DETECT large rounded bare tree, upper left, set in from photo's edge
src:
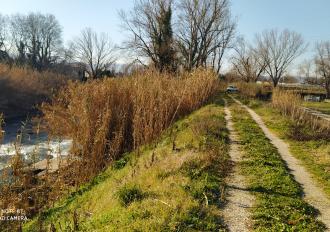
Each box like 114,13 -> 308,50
11,13 -> 62,70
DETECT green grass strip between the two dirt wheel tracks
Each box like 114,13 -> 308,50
232,104 -> 325,231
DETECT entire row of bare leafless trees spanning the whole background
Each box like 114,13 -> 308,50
0,0 -> 330,96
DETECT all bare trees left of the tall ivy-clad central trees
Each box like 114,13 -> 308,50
0,13 -> 115,78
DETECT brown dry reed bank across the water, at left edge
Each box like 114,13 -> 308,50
0,64 -> 72,118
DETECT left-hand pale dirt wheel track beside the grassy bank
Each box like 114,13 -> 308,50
223,99 -> 254,232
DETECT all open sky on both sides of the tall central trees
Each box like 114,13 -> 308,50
0,0 -> 330,72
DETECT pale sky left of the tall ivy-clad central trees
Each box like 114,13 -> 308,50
0,0 -> 133,43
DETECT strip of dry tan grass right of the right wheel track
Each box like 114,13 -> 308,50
272,89 -> 330,137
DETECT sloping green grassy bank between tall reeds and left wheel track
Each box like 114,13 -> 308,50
23,95 -> 230,232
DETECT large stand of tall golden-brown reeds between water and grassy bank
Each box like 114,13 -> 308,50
42,70 -> 218,181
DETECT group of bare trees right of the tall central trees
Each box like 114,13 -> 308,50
231,30 -> 330,98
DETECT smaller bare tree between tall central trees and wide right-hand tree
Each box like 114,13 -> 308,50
231,38 -> 266,82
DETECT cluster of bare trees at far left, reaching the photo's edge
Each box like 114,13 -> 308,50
0,13 -> 62,70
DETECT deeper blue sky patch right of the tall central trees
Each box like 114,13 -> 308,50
232,0 -> 330,50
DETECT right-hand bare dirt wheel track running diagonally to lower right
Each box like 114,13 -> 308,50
233,98 -> 330,230
